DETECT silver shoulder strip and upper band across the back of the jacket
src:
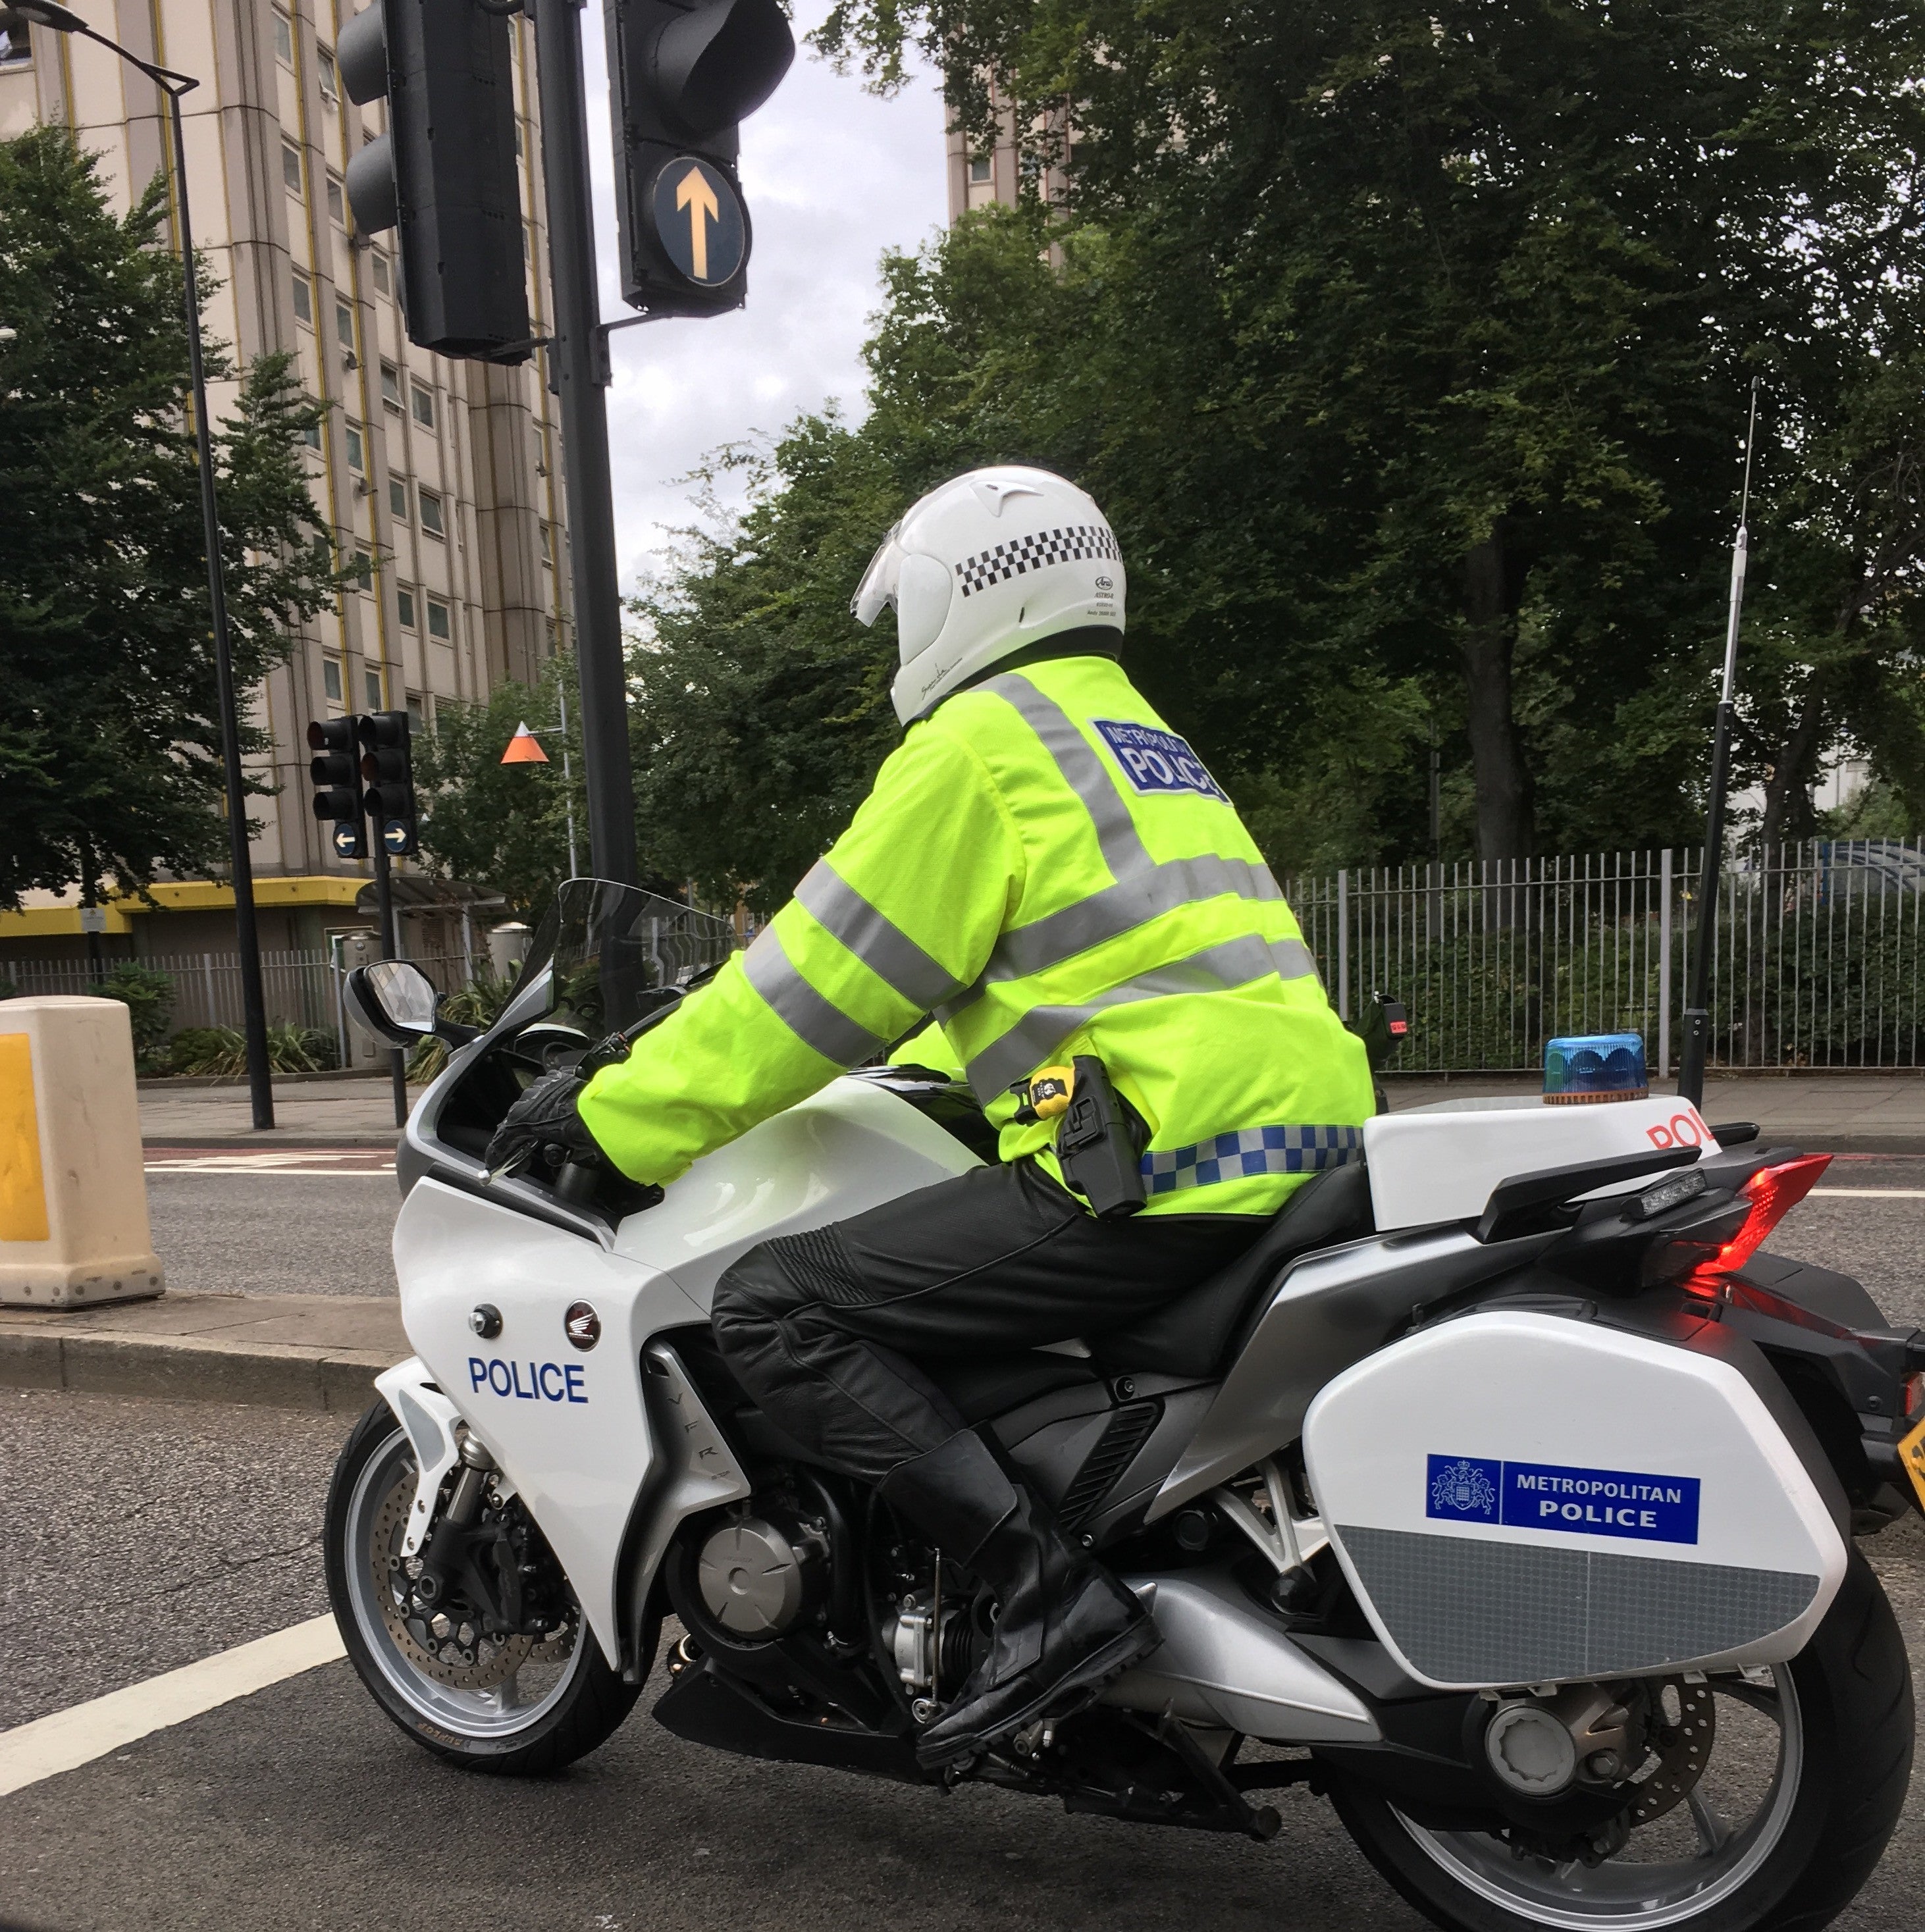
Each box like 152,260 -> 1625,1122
937,672 -> 1316,1024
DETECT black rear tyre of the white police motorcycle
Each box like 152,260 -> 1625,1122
1328,1550 -> 1913,1932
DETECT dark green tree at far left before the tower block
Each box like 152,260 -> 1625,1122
0,128 -> 336,906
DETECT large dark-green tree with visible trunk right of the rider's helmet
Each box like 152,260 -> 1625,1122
788,0 -> 1925,858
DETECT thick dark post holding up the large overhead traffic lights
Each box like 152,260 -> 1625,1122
533,0 -> 636,885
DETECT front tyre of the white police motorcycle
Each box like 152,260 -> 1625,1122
325,1401 -> 649,1777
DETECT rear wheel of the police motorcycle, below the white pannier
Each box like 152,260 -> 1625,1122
1332,1550 -> 1911,1932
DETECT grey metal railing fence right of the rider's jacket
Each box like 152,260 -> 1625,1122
1283,841 -> 1925,1072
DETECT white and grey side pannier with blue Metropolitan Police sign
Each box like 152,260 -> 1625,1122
1303,1310 -> 1846,1688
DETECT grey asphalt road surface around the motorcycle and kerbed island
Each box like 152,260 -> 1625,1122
0,1161 -> 1925,1932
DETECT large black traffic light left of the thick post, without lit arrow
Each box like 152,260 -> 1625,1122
334,0 -> 525,363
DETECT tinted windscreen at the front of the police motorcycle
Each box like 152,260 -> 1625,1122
522,879 -> 737,1039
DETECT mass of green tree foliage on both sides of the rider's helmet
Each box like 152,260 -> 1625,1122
634,0 -> 1925,889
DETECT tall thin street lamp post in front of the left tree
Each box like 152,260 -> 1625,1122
0,0 -> 275,1128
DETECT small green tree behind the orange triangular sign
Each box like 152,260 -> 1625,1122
413,657 -> 587,922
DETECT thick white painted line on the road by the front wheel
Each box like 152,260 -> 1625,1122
0,1617 -> 348,1797
